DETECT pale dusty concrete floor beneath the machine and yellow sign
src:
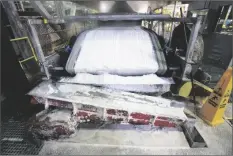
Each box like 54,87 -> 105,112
40,105 -> 232,155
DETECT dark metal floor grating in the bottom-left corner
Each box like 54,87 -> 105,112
1,119 -> 43,155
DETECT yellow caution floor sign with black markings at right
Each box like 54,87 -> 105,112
200,67 -> 232,126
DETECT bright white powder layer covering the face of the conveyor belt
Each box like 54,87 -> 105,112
72,27 -> 158,75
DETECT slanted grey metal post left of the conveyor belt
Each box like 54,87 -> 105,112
29,21 -> 50,79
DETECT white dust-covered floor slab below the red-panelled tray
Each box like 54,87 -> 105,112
40,129 -> 189,149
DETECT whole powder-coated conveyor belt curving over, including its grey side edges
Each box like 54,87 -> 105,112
66,27 -> 167,75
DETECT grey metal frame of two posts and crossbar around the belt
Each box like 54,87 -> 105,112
28,14 -> 202,80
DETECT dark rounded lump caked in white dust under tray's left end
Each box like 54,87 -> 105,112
29,109 -> 77,140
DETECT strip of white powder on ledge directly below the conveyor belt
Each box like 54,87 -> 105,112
59,73 -> 174,93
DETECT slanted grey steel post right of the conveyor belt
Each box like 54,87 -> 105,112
182,16 -> 202,80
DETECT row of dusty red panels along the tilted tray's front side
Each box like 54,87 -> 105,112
31,95 -> 182,127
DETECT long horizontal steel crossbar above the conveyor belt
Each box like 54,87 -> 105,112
27,14 -> 195,24
